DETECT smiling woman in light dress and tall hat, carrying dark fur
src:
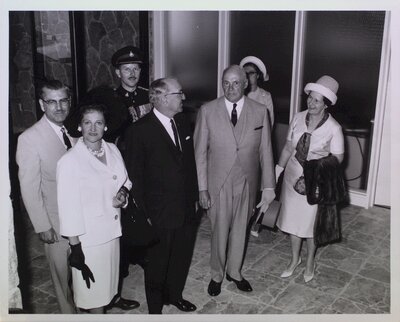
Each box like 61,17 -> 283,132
275,76 -> 344,283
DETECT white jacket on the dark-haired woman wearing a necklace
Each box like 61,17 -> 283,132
57,140 -> 132,247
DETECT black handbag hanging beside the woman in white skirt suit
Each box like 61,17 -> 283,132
121,195 -> 159,246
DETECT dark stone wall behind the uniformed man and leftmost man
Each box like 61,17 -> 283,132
9,11 -> 148,133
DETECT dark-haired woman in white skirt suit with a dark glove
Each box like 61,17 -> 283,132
57,104 -> 132,313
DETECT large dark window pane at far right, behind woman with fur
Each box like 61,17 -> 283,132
303,11 -> 385,189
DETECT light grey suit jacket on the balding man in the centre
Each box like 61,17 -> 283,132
194,97 -> 275,204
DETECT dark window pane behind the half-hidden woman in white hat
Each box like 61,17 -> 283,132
230,11 -> 295,124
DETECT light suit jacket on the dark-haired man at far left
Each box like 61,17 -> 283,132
16,115 -> 77,233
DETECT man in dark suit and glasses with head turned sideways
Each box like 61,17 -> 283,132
125,78 -> 198,314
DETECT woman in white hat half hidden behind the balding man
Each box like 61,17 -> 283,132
239,56 -> 274,128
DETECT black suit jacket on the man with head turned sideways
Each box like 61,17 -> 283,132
125,111 -> 198,229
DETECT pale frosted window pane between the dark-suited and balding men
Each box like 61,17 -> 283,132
165,11 -> 218,111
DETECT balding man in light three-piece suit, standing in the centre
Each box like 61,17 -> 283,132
194,65 -> 275,296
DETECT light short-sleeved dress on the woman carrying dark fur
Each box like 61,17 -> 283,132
277,110 -> 344,238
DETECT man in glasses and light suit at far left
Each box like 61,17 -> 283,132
16,80 -> 76,314
